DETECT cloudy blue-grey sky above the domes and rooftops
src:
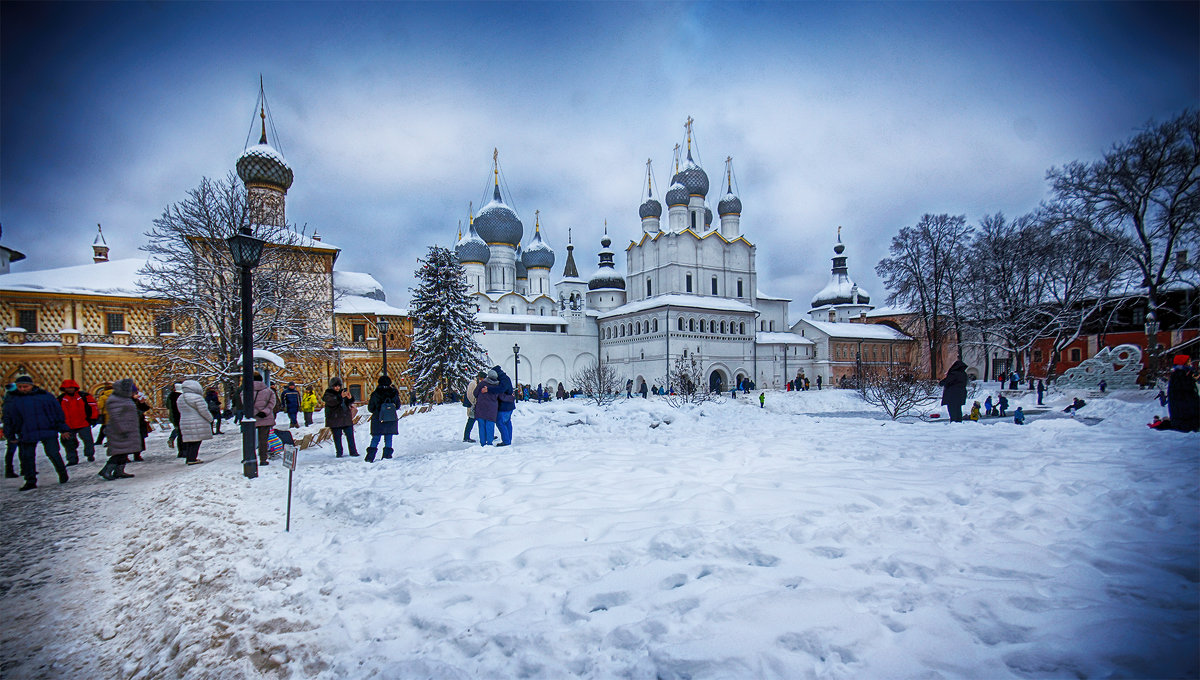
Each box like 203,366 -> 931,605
0,2 -> 1200,320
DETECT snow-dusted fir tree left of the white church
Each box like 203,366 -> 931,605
408,246 -> 485,395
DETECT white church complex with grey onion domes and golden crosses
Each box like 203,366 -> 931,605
455,119 -> 913,392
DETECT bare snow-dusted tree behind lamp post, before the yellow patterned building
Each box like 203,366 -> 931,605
139,173 -> 334,398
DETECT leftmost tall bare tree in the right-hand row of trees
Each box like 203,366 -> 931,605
875,215 -> 971,378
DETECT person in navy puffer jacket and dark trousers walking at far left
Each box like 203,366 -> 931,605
4,375 -> 68,491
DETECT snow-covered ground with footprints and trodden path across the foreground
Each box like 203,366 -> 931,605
0,390 -> 1200,679
